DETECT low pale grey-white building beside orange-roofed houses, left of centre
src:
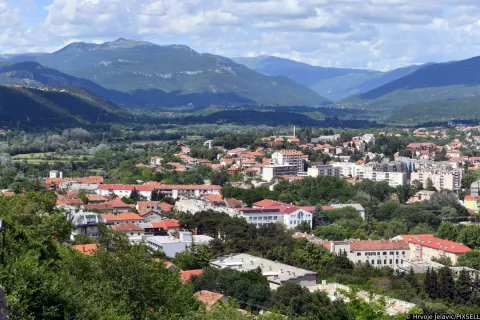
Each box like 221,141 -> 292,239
146,231 -> 213,258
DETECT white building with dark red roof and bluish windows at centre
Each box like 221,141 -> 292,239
235,205 -> 313,229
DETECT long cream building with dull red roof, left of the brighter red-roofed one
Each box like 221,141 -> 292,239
318,239 -> 410,269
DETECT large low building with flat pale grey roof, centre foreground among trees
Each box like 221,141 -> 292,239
210,253 -> 317,289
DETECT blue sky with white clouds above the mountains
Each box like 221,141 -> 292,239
0,0 -> 480,70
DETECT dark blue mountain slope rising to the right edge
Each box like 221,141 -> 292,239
341,57 -> 480,111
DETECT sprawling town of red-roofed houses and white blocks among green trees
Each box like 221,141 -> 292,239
0,126 -> 480,316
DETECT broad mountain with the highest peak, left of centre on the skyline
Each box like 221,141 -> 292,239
9,39 -> 327,106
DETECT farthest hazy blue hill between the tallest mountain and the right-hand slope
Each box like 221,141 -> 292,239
233,56 -> 421,101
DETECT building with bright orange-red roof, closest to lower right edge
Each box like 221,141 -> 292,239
394,234 -> 472,264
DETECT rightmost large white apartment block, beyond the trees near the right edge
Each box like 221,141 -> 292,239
410,168 -> 463,191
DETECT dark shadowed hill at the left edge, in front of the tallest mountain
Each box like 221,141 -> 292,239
0,86 -> 120,124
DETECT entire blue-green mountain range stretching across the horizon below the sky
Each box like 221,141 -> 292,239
0,38 -> 480,122
